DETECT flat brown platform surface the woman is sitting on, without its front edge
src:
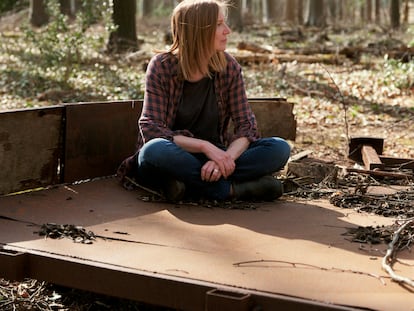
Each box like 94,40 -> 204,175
0,179 -> 414,310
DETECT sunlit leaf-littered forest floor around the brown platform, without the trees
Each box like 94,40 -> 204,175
0,13 -> 414,310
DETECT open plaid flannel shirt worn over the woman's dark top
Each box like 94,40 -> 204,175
118,52 -> 259,183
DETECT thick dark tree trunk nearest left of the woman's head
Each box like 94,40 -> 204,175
107,0 -> 139,53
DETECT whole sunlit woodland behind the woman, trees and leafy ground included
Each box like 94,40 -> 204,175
0,0 -> 414,310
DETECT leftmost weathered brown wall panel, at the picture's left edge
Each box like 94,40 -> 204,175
0,107 -> 63,194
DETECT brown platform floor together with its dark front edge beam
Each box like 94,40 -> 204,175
0,178 -> 414,311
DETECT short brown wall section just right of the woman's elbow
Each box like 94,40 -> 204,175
249,98 -> 296,141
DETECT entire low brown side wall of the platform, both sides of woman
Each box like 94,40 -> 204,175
0,98 -> 296,189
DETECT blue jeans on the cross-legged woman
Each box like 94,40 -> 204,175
136,137 -> 290,200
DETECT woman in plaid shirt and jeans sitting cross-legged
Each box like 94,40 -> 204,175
118,0 -> 290,201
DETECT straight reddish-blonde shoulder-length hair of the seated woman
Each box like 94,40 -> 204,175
169,0 -> 227,80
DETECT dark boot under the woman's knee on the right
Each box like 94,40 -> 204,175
233,176 -> 283,201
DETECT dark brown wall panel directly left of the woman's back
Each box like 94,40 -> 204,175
64,101 -> 142,182
